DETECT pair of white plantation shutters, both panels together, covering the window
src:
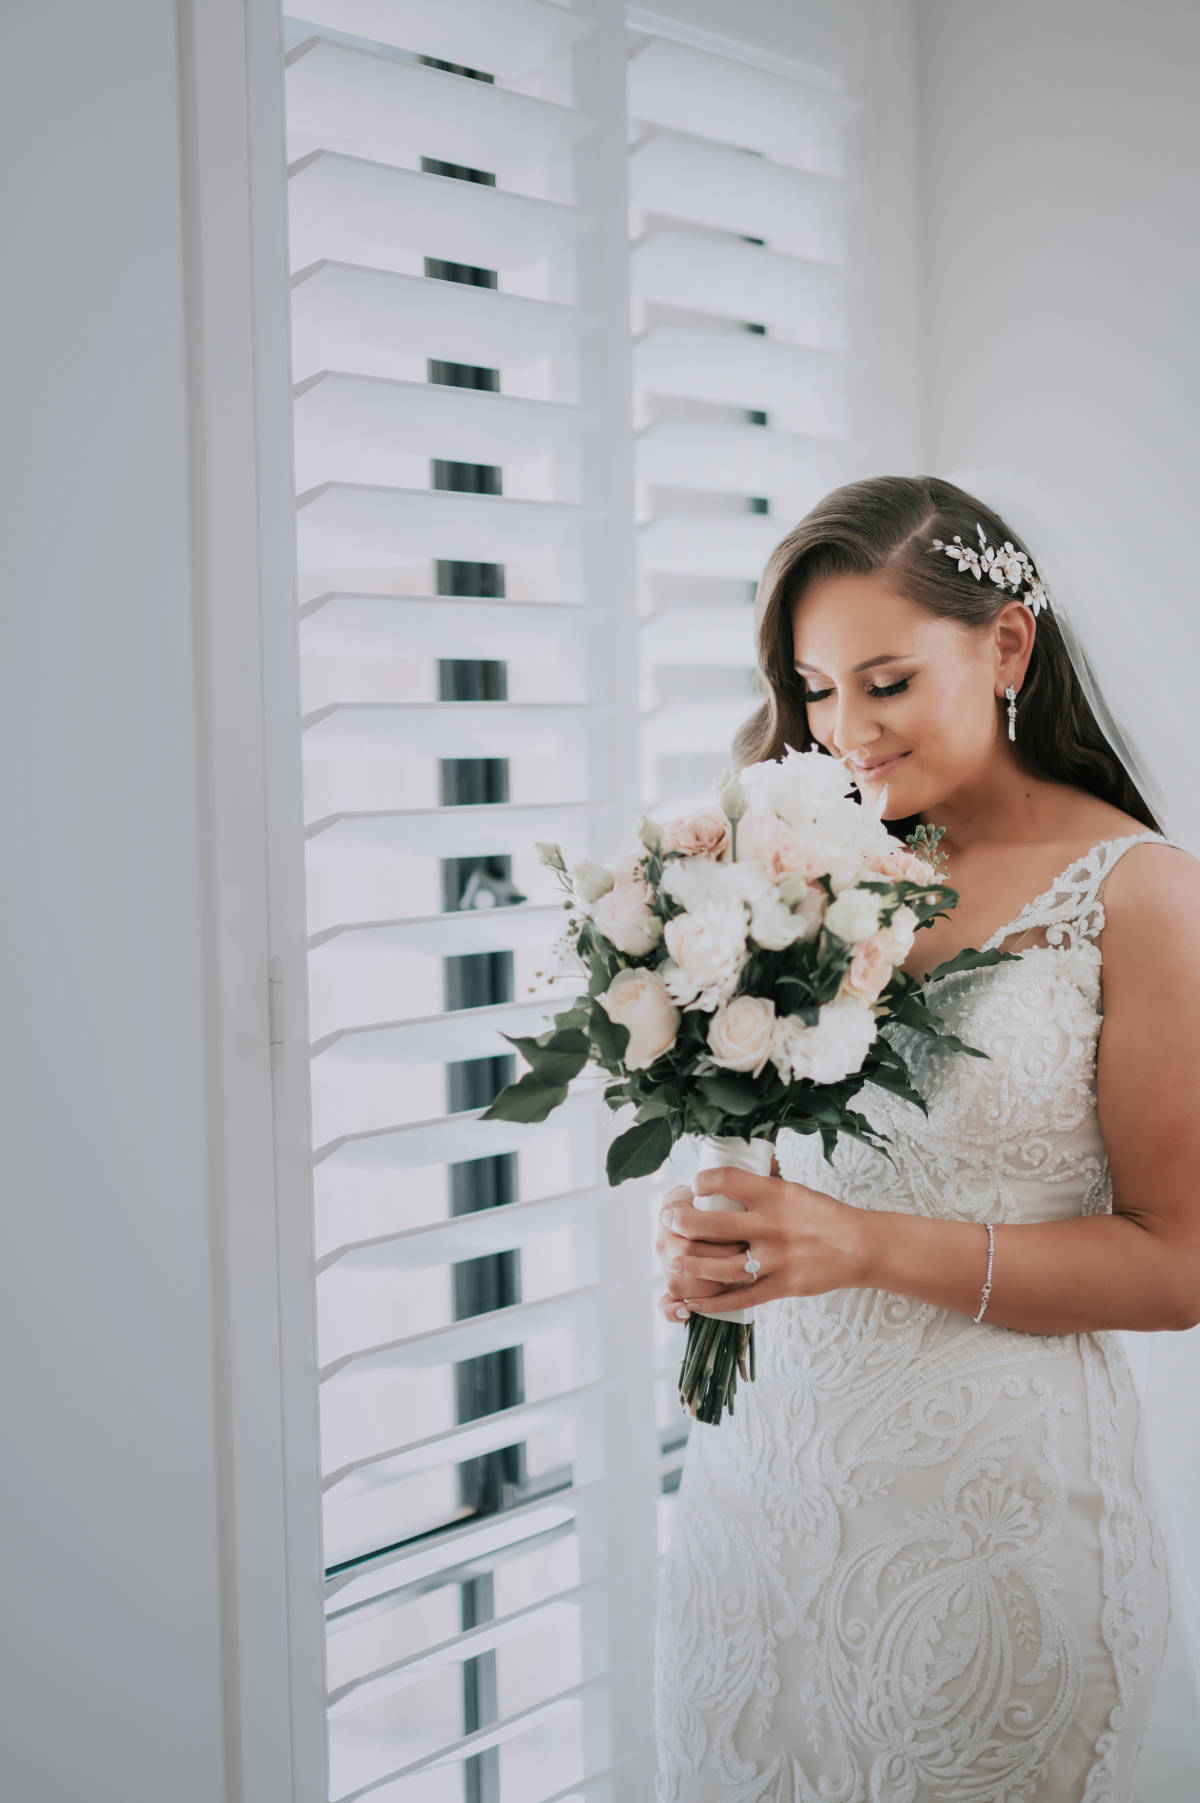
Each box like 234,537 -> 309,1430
285,0 -> 850,1803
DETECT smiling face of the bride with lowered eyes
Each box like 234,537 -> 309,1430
793,573 -> 1004,820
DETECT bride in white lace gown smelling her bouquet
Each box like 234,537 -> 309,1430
654,476 -> 1200,1803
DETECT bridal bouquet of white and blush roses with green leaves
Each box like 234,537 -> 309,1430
483,746 -> 1009,1423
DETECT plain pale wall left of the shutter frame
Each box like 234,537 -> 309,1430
0,0 -> 225,1803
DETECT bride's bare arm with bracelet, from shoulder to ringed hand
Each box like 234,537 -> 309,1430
672,846 -> 1200,1334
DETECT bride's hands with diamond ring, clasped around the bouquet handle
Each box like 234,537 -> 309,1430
663,1165 -> 868,1314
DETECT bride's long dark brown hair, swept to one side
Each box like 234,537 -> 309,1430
733,476 -> 1160,831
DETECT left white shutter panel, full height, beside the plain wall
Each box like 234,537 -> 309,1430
285,0 -> 656,1803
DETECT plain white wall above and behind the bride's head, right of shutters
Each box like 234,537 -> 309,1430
915,0 -> 1200,842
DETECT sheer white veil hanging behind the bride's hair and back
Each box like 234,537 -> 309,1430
948,467 -> 1200,1803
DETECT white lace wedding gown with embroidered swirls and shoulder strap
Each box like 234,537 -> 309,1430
654,833 -> 1175,1803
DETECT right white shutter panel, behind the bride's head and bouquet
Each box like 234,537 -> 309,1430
629,7 -> 854,811
